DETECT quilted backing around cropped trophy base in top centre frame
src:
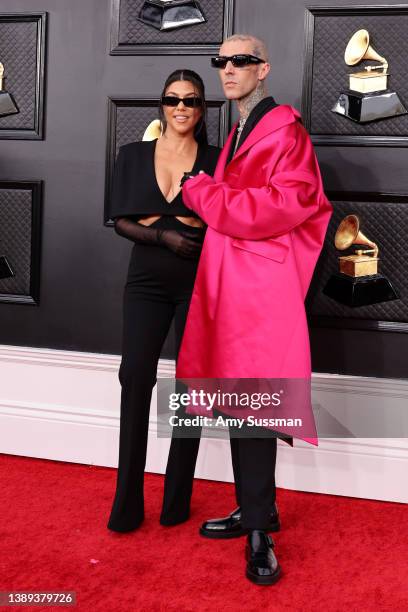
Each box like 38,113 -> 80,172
116,0 -> 229,52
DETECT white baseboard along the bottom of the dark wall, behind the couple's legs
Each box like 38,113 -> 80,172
0,345 -> 408,503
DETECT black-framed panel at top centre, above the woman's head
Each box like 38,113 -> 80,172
110,0 -> 233,55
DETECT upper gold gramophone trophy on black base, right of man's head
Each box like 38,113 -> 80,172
332,30 -> 408,123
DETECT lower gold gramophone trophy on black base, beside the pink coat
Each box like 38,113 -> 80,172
323,215 -> 399,307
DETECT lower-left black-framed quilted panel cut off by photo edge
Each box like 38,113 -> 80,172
0,181 -> 42,305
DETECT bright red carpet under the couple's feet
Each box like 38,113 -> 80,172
0,455 -> 408,612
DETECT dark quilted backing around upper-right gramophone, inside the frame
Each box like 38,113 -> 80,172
309,9 -> 408,136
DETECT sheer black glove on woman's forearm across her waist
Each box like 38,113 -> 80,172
115,217 -> 204,258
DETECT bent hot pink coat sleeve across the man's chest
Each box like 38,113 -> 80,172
183,122 -> 323,240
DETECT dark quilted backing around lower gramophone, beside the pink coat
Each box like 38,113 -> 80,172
306,196 -> 408,322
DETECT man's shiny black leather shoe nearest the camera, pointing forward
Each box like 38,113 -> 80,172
245,530 -> 281,585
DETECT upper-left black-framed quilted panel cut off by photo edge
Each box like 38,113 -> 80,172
0,13 -> 47,140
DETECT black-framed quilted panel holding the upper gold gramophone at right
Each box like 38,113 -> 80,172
302,5 -> 408,147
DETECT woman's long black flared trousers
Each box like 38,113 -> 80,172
108,216 -> 203,531
